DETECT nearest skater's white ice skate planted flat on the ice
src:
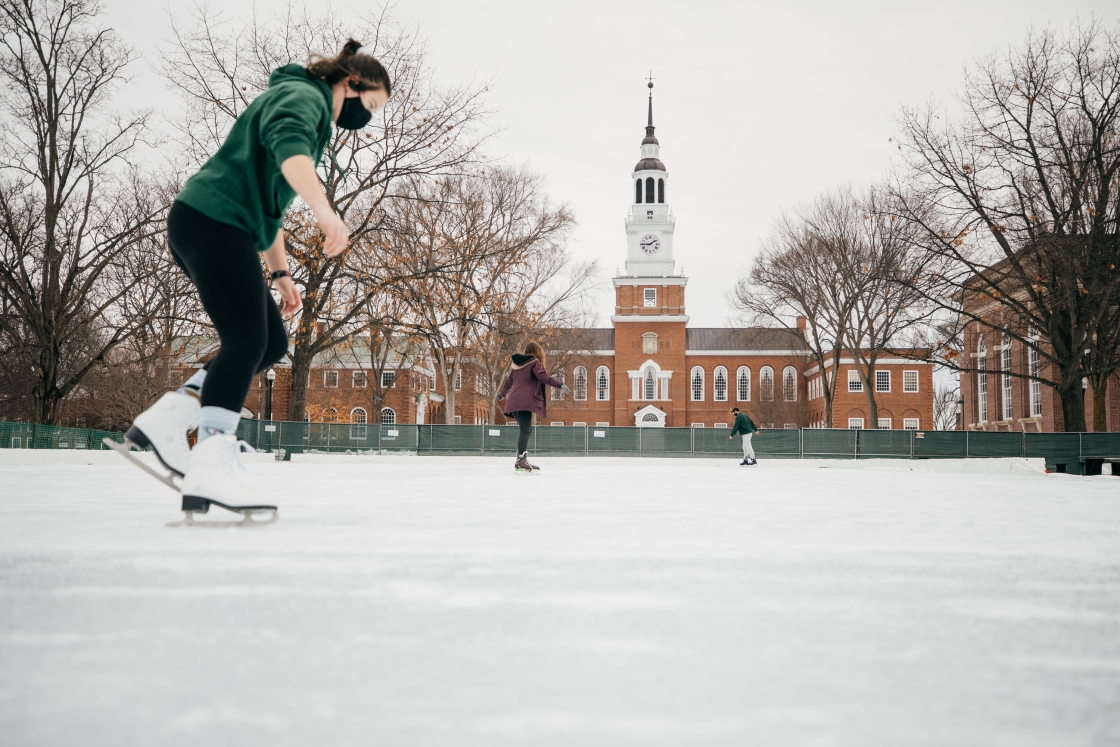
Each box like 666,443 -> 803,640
170,433 -> 278,526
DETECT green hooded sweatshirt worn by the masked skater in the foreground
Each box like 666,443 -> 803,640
176,65 -> 334,252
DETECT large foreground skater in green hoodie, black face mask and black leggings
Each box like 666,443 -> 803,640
125,39 -> 392,511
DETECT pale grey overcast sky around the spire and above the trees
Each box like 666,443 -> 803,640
105,0 -> 1118,327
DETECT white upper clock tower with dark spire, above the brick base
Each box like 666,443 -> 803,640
626,81 -> 675,278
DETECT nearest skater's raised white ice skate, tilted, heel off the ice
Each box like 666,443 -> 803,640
104,392 -> 200,491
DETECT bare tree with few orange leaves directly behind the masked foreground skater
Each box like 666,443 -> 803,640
161,2 -> 486,420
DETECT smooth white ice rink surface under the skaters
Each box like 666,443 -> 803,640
0,452 -> 1120,747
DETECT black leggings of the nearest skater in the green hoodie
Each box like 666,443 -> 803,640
167,202 -> 288,412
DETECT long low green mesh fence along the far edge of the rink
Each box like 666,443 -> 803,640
0,420 -> 1120,474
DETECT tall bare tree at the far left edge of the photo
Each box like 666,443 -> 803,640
0,0 -> 167,422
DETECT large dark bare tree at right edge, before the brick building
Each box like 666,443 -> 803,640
896,21 -> 1120,431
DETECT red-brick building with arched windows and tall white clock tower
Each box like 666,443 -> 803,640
457,85 -> 933,429
